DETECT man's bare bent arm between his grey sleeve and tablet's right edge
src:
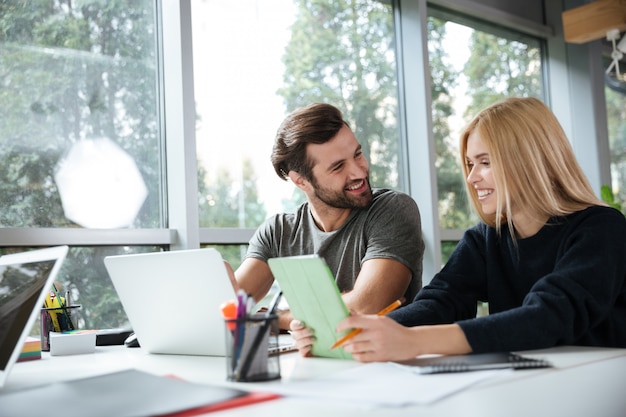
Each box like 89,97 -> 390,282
342,258 -> 413,314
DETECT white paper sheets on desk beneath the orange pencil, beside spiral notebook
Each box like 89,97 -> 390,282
268,362 -> 512,408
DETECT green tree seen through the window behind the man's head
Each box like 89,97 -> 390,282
278,0 -> 399,188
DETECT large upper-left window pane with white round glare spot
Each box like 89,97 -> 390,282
0,0 -> 162,228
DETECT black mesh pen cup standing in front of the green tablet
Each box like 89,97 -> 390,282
225,314 -> 280,382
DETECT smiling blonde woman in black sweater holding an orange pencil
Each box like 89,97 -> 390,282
292,98 -> 626,362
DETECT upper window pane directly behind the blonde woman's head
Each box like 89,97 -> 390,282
428,9 -> 543,229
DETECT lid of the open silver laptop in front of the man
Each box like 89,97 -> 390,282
104,248 -> 236,356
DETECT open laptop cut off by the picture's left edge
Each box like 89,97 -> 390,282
0,246 -> 69,387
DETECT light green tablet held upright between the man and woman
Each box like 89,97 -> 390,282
268,255 -> 352,359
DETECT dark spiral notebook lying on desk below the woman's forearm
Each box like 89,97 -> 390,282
396,352 -> 552,374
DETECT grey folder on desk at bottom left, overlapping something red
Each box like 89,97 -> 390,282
0,369 -> 254,417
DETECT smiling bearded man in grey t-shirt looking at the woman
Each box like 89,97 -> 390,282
235,103 -> 424,329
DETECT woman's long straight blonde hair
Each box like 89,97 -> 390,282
459,98 -> 605,233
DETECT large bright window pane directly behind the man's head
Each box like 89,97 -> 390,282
191,0 -> 401,228
